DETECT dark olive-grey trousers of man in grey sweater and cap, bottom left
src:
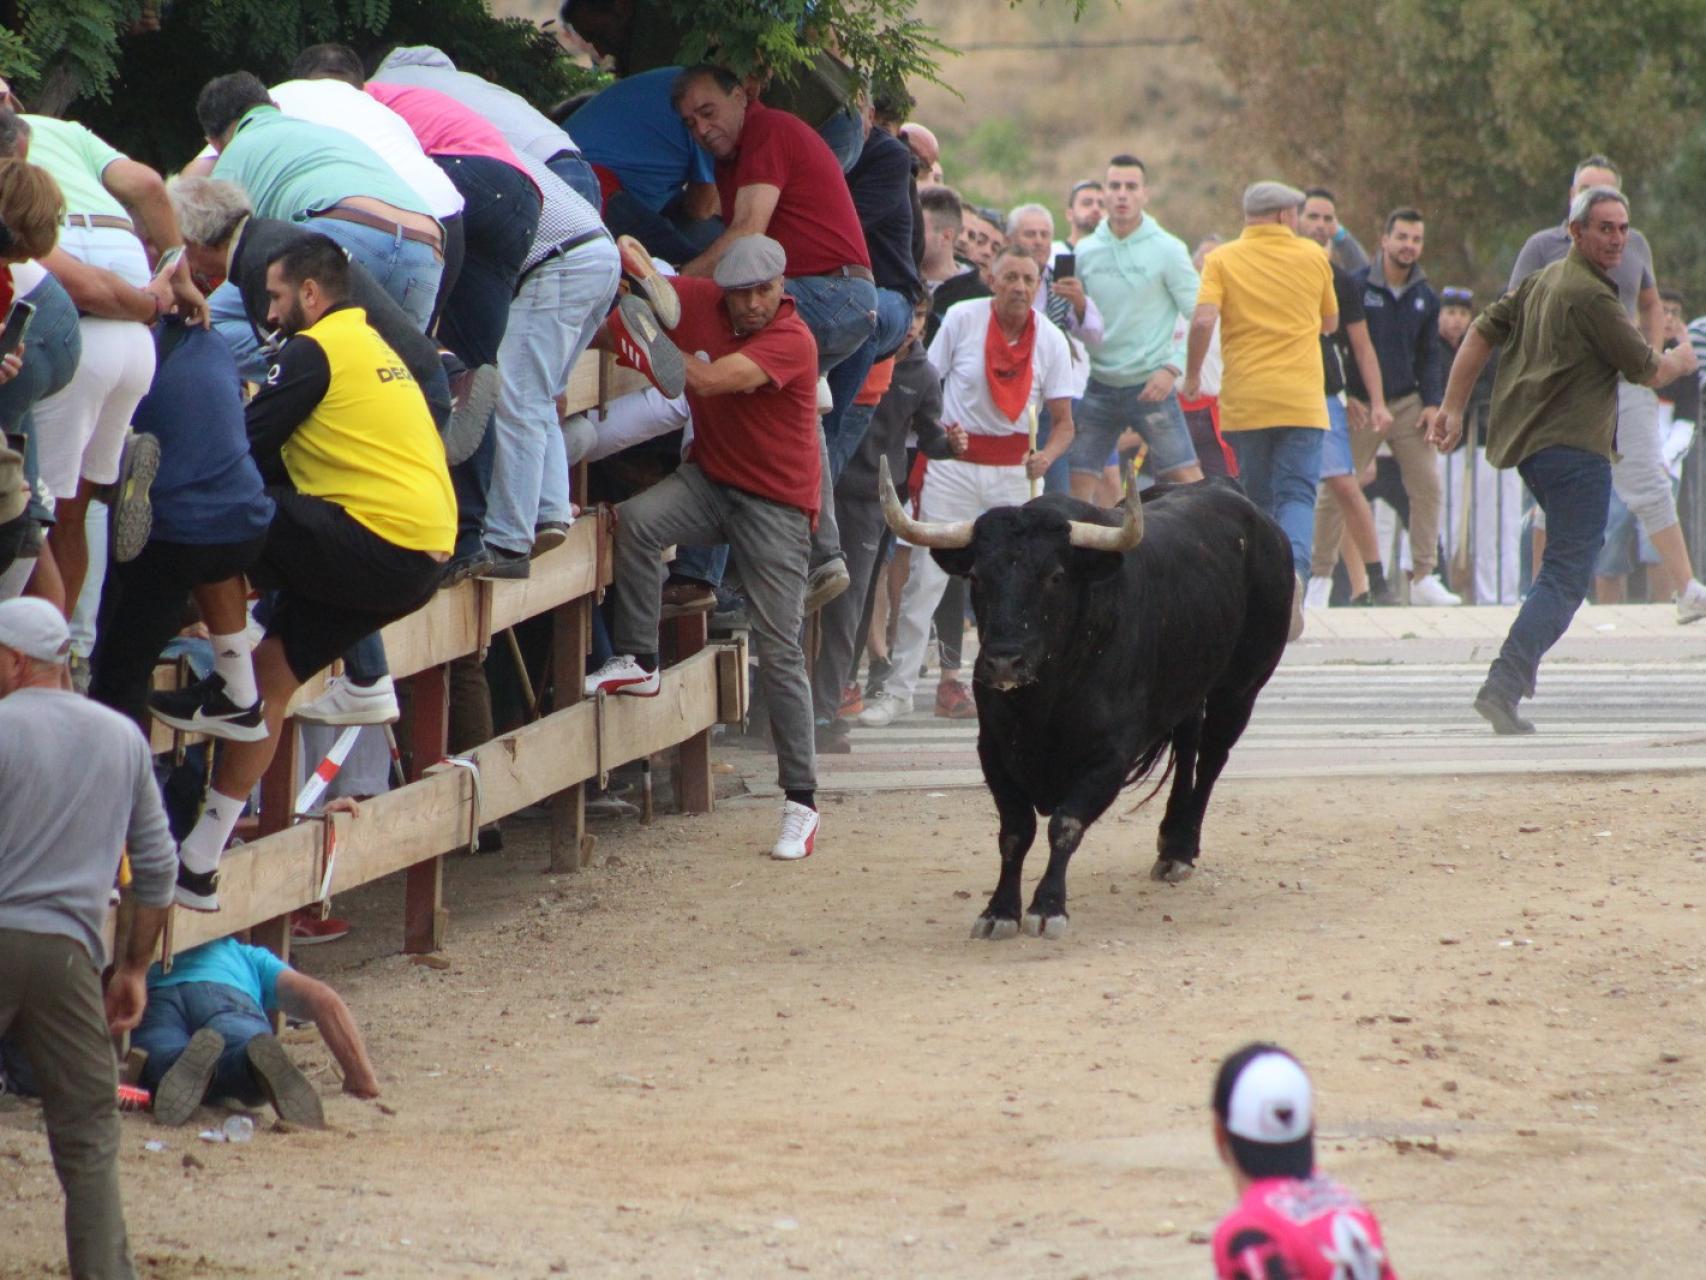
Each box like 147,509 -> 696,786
0,928 -> 136,1280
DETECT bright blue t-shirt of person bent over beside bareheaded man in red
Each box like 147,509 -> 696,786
563,67 -> 717,213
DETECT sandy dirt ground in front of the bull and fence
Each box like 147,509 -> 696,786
0,777 -> 1706,1280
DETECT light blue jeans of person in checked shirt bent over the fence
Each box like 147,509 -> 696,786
486,237 -> 621,553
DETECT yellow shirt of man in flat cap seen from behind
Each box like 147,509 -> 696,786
1196,222 -> 1339,432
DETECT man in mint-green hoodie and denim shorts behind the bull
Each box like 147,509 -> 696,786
1066,155 -> 1203,500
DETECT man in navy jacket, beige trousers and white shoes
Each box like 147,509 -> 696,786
1337,208 -> 1462,604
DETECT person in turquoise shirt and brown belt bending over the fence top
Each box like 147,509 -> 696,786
196,72 -> 444,333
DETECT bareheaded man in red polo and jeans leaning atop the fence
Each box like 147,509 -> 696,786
670,65 -> 877,611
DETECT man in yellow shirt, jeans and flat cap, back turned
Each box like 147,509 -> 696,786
1184,183 -> 1339,640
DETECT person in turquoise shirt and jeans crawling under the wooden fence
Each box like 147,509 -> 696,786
130,937 -> 379,1128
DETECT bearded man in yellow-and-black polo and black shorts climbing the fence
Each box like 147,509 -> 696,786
165,236 -> 456,911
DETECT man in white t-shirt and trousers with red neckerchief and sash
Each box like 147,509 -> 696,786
860,244 -> 1073,725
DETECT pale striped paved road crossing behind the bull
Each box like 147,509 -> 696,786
749,635 -> 1706,794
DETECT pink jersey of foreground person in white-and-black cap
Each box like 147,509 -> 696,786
1215,1174 -> 1397,1280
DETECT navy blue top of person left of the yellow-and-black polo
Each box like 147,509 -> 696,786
131,321 -> 273,546
